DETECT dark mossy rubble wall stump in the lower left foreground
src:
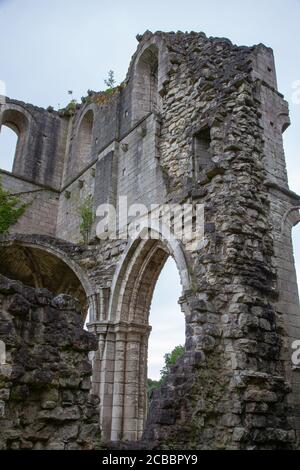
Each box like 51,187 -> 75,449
0,276 -> 100,450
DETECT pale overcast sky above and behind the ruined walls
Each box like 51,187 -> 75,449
0,0 -> 300,377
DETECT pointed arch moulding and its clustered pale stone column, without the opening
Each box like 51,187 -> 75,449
93,228 -> 189,441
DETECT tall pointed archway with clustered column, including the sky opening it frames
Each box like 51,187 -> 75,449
101,237 -> 190,441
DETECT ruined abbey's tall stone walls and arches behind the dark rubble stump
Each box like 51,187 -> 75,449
0,32 -> 300,449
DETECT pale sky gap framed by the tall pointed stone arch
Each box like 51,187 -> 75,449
148,257 -> 185,394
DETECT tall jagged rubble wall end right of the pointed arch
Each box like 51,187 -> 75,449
100,34 -> 299,449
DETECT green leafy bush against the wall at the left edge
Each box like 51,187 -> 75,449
0,180 -> 29,234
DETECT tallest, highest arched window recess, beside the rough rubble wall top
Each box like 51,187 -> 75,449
132,45 -> 159,122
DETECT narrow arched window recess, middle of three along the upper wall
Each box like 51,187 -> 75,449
77,110 -> 94,169
